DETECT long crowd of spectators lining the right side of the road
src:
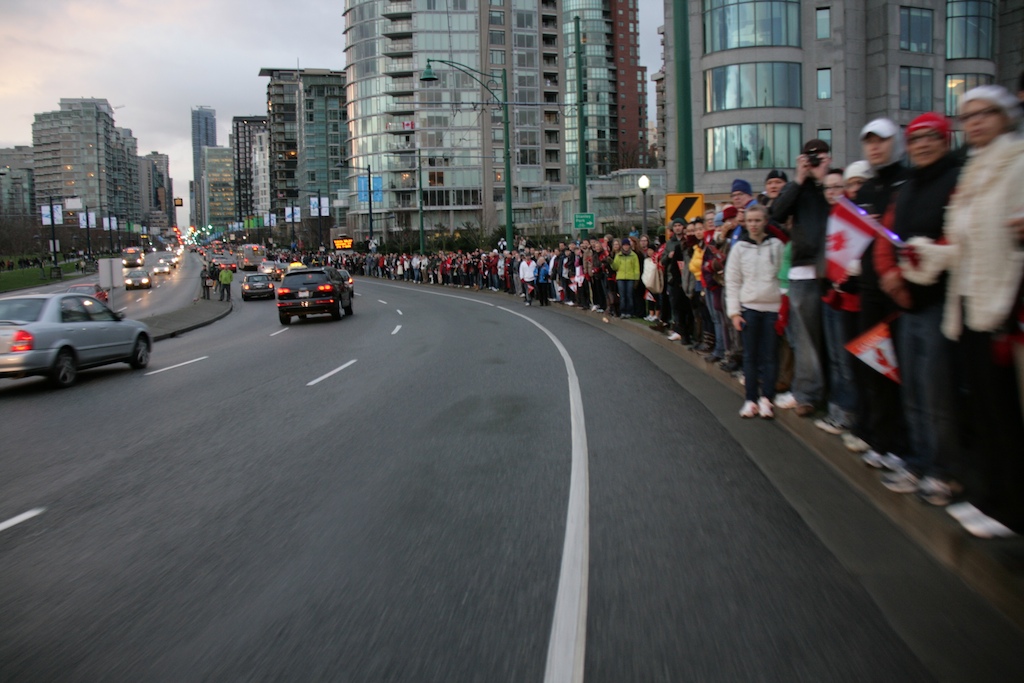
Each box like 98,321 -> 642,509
350,83 -> 1024,538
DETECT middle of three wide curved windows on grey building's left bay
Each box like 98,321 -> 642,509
705,61 -> 802,113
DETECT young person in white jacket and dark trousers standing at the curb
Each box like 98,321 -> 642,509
725,205 -> 782,418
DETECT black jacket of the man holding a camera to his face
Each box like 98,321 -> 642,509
771,176 -> 831,275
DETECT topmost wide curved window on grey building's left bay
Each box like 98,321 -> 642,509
703,0 -> 800,53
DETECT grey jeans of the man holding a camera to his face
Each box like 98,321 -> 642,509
788,280 -> 825,404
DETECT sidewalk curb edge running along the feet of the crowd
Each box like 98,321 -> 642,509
552,305 -> 1024,629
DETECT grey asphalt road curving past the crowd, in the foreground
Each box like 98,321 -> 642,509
0,280 -> 1021,682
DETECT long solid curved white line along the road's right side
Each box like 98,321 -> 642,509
498,306 -> 590,683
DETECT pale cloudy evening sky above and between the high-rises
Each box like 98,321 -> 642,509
0,0 -> 664,225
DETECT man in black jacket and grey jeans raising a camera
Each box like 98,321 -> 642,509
771,139 -> 831,417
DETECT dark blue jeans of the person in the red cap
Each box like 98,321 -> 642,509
896,303 -> 958,474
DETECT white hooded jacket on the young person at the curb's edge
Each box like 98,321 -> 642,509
725,233 -> 782,317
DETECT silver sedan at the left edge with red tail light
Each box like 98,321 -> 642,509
0,293 -> 153,388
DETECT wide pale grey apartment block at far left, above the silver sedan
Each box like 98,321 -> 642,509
32,98 -> 142,224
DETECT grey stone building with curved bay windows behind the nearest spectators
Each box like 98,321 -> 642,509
665,0 -> 1024,193
